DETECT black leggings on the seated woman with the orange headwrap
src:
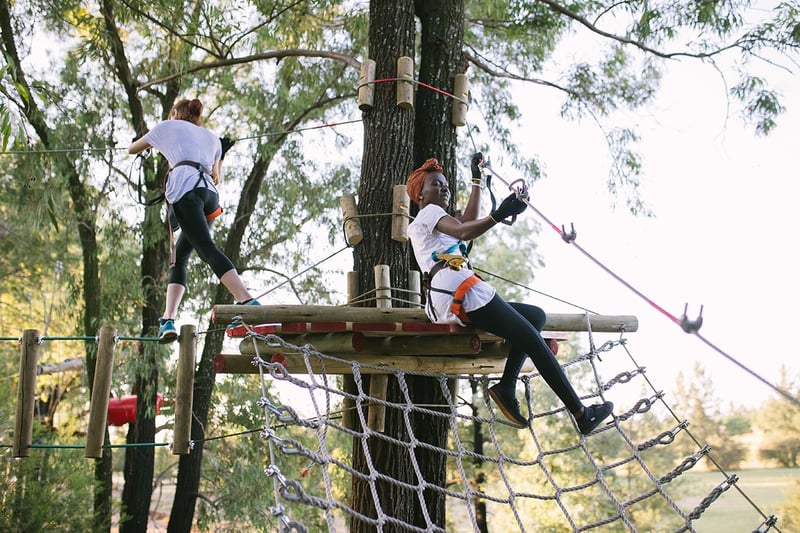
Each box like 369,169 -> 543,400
467,294 -> 583,413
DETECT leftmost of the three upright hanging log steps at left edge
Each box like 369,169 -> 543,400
11,329 -> 39,457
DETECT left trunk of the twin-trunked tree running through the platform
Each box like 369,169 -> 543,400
350,0 -> 460,532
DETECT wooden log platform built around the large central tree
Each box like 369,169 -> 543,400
212,305 -> 638,374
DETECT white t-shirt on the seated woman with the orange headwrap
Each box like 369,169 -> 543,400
408,204 -> 495,325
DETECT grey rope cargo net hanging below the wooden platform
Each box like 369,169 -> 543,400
236,327 -> 779,532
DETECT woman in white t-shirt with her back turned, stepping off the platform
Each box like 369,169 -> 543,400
128,98 -> 258,343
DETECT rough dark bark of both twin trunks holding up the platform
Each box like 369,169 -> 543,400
350,0 -> 464,532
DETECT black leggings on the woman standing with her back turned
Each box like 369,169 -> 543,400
169,187 -> 234,287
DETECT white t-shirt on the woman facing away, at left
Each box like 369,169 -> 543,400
143,120 -> 222,204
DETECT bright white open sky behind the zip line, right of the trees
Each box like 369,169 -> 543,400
500,53 -> 800,404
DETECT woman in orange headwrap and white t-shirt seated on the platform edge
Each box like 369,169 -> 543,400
406,153 -> 614,435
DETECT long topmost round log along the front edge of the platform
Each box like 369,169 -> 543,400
212,305 -> 639,333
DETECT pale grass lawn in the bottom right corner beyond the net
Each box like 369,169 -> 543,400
678,468 -> 800,533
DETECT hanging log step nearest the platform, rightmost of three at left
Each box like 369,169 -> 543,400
172,324 -> 197,455
